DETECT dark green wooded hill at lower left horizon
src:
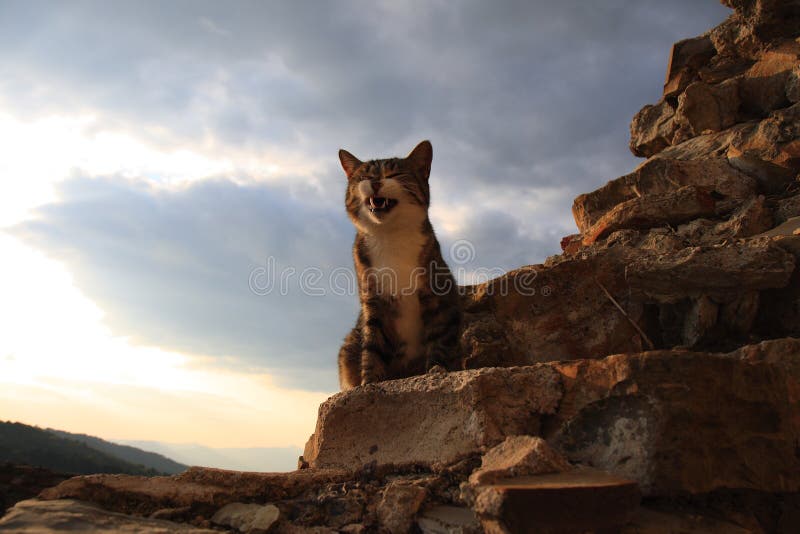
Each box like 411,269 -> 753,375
0,421 -> 174,476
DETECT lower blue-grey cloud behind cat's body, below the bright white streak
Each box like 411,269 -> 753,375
10,171 -> 568,391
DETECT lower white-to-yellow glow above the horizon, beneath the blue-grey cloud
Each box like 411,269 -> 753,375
0,237 -> 327,447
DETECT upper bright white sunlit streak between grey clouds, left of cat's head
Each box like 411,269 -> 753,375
0,113 -> 315,227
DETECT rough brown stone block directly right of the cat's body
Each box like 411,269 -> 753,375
462,255 -> 642,368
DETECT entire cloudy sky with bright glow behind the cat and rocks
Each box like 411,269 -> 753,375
0,0 -> 729,456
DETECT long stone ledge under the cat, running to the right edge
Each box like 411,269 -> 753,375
305,339 -> 800,495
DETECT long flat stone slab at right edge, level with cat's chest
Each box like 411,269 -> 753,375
626,240 -> 795,301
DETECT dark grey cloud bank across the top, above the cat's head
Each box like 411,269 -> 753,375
0,0 -> 728,190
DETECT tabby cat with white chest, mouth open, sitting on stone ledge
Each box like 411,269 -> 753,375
339,141 -> 461,390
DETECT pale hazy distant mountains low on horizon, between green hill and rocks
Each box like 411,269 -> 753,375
118,440 -> 303,473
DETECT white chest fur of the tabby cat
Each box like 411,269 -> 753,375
368,232 -> 425,359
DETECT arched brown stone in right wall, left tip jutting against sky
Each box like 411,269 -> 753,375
572,158 -> 757,234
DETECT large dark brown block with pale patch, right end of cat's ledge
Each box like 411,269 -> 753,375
545,339 -> 800,495
